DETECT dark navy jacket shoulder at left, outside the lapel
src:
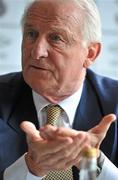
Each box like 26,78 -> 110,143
0,72 -> 29,118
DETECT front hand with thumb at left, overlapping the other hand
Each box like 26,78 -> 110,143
21,121 -> 73,176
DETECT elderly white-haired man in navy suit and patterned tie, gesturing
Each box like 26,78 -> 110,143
0,0 -> 118,180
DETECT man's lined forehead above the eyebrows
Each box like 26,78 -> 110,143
25,0 -> 78,29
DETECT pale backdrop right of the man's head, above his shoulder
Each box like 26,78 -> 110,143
92,0 -> 118,79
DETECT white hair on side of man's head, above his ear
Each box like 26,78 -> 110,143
76,0 -> 102,43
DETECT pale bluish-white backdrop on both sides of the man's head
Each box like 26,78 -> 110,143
0,0 -> 118,79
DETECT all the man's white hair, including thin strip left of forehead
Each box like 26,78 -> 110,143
22,0 -> 102,44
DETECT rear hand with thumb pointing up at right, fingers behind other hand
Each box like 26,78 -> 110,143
40,114 -> 116,168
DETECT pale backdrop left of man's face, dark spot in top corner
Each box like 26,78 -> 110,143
0,0 -> 30,74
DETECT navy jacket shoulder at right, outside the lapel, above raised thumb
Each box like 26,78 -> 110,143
86,70 -> 118,114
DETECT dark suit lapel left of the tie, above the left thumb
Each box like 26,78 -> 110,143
8,80 -> 39,132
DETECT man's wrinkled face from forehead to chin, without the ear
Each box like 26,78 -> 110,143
22,1 -> 88,103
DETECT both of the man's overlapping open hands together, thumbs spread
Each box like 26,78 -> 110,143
21,114 -> 116,176
